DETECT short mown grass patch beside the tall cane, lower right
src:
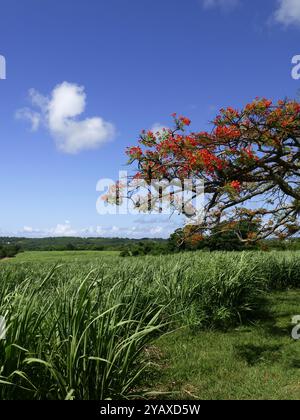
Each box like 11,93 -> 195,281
148,290 -> 300,400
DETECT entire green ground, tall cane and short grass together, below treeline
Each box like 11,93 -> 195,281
0,251 -> 300,399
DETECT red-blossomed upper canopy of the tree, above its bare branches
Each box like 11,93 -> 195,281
127,98 -> 300,199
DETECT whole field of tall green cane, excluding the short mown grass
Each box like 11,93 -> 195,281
0,252 -> 300,399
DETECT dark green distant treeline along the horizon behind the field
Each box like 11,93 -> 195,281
0,235 -> 300,259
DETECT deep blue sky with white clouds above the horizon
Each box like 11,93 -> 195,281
0,0 -> 300,237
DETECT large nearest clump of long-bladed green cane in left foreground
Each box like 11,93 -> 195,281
0,267 -> 163,400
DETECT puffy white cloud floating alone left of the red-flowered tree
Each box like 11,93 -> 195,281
16,82 -> 116,154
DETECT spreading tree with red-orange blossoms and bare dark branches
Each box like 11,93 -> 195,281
110,98 -> 300,241
